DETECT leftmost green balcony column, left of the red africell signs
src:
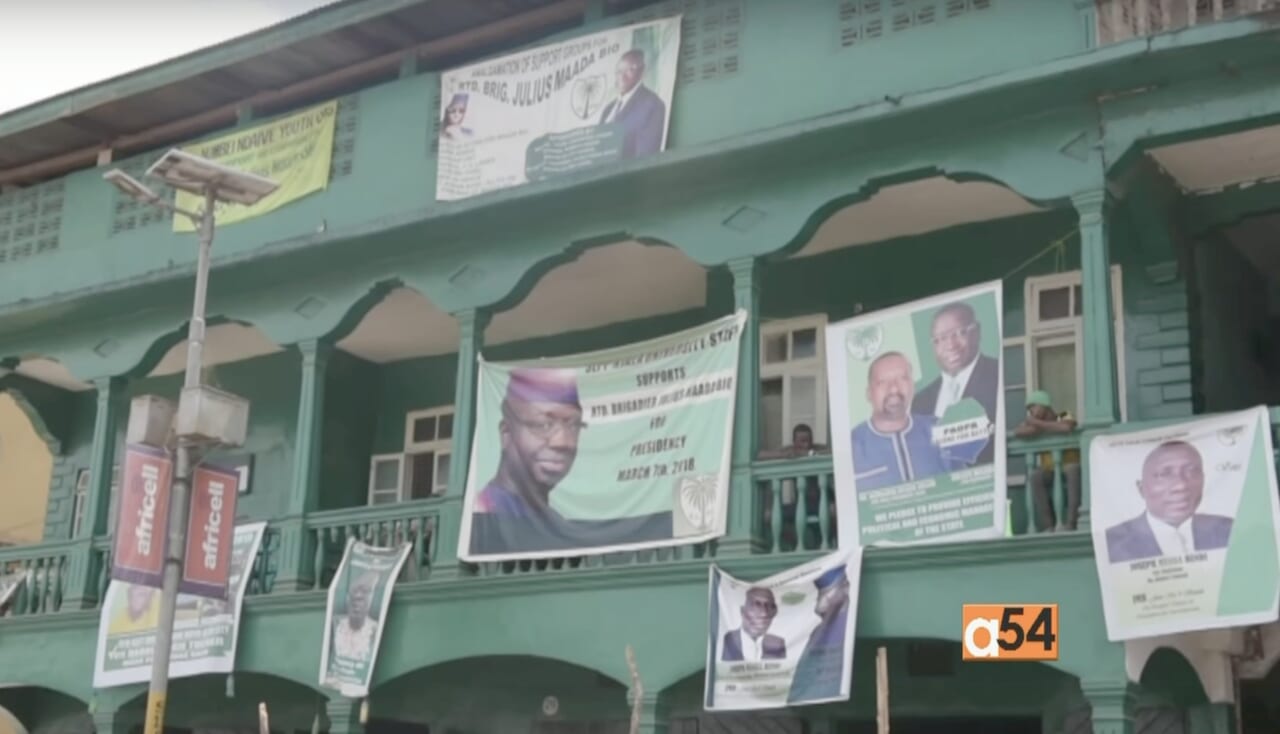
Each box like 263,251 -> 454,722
63,377 -> 124,610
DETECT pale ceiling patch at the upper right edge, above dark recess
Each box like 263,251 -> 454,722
1148,126 -> 1280,193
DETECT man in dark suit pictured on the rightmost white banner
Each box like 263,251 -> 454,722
1107,441 -> 1231,564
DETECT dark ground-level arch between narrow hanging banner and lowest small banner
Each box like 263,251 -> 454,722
369,656 -> 631,734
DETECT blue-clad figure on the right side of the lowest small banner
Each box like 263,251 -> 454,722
787,565 -> 851,703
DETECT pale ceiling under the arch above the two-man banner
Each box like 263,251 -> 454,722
795,177 -> 1043,257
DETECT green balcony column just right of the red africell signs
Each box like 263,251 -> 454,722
273,339 -> 333,591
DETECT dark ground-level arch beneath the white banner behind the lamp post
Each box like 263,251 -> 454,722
113,673 -> 325,734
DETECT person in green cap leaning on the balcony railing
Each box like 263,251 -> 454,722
1014,389 -> 1080,532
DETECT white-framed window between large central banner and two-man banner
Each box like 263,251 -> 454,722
760,314 -> 827,451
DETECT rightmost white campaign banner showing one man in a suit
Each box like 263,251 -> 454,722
1089,406 -> 1280,640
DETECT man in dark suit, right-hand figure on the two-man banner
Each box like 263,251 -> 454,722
911,301 -> 1000,466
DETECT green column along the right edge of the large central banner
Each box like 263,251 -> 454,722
721,257 -> 760,555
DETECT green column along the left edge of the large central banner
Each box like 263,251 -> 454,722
431,309 -> 489,578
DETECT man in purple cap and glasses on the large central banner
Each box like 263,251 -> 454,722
471,368 -> 672,553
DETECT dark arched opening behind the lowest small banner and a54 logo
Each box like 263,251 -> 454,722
663,638 -> 1059,734
